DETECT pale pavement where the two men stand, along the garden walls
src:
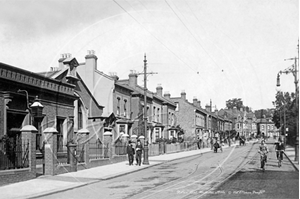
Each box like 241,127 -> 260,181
0,141 -> 299,199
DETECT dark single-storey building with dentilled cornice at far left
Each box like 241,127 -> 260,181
0,63 -> 77,150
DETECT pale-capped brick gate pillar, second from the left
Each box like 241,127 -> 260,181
43,127 -> 57,176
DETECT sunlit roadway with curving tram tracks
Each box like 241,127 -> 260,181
35,144 -> 268,199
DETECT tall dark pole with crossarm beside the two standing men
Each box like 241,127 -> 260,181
138,53 -> 157,165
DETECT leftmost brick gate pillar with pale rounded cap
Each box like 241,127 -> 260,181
21,125 -> 37,178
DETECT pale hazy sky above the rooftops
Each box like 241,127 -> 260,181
0,0 -> 299,110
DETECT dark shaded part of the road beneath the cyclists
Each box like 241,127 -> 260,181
200,143 -> 299,199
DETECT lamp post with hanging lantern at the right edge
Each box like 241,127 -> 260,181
277,54 -> 299,163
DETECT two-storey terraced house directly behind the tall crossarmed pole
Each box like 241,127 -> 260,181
117,72 -> 176,143
